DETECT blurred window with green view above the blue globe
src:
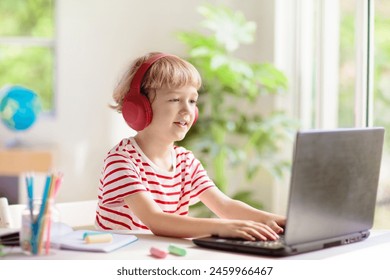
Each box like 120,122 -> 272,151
0,0 -> 55,112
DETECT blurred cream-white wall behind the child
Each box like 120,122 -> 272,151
0,0 -> 274,210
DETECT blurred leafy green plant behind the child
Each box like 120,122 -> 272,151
177,2 -> 292,217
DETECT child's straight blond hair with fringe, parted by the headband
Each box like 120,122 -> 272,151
110,52 -> 202,112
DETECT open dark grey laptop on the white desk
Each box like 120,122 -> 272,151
192,127 -> 384,256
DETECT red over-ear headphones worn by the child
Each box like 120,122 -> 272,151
122,53 -> 198,131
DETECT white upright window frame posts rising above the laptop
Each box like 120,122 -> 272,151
276,0 -> 374,129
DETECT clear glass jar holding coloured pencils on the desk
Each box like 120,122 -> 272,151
20,199 -> 60,255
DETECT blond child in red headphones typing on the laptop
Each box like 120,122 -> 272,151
96,53 -> 285,240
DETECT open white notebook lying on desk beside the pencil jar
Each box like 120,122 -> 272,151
50,230 -> 138,253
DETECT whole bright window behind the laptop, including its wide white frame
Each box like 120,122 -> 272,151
288,0 -> 390,228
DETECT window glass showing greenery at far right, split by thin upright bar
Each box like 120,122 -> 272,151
338,0 -> 390,228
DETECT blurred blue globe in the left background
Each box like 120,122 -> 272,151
0,86 -> 41,131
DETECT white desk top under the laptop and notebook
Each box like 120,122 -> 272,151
0,230 -> 390,262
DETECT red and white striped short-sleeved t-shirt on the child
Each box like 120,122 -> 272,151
95,138 -> 215,230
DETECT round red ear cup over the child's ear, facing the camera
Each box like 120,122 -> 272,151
122,92 -> 153,131
